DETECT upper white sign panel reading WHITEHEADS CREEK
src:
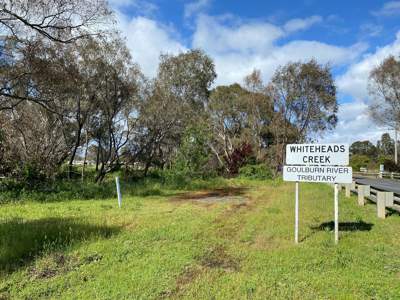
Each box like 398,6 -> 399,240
286,144 -> 349,166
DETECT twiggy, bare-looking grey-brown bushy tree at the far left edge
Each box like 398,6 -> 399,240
0,102 -> 70,179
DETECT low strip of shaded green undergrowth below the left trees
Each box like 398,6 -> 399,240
0,170 -> 225,204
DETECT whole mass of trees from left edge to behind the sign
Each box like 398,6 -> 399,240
0,0 -> 344,183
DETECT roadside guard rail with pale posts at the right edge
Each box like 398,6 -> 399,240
340,181 -> 400,218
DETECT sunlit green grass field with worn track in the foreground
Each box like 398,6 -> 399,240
0,179 -> 400,299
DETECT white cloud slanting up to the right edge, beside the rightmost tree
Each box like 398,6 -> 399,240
337,31 -> 400,101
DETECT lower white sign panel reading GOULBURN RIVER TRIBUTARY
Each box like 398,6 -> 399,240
283,166 -> 353,183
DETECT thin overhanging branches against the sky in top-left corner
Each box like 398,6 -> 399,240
0,0 -> 111,43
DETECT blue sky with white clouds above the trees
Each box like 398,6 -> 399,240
110,0 -> 400,143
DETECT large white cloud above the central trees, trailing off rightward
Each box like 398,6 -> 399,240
192,15 -> 366,84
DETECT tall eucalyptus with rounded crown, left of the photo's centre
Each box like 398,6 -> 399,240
128,50 -> 216,174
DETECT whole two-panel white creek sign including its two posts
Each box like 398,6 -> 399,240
283,144 -> 353,244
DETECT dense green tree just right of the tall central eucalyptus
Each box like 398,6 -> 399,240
207,84 -> 272,174
